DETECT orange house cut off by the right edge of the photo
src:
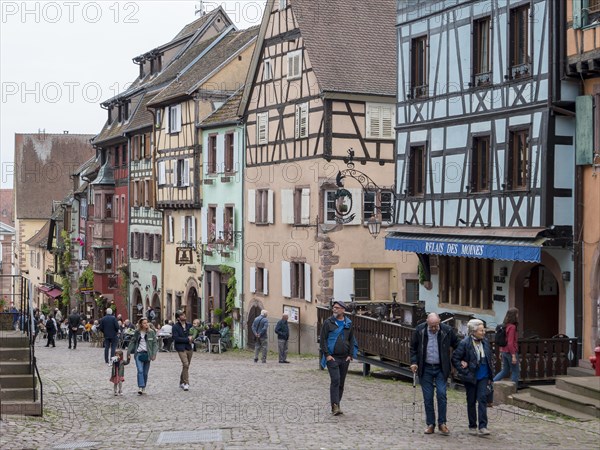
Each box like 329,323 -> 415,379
564,0 -> 600,363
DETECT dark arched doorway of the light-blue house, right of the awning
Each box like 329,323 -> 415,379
520,264 -> 560,338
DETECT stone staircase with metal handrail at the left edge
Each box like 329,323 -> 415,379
0,332 -> 42,416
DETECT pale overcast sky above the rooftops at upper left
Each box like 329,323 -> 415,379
0,0 -> 266,188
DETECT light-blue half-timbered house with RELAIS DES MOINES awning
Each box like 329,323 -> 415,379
386,0 -> 578,337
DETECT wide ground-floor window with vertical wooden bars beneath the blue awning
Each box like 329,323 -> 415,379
438,256 -> 494,309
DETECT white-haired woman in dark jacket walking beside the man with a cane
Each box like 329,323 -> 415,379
452,319 -> 494,436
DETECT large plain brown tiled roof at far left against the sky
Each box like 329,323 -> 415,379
14,134 -> 95,219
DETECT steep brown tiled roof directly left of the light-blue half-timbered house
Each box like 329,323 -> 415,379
291,0 -> 397,96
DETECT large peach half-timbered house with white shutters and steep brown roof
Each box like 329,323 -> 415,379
240,0 -> 418,352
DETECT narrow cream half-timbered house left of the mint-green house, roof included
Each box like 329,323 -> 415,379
148,26 -> 258,320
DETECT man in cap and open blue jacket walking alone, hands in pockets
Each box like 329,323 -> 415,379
320,300 -> 358,416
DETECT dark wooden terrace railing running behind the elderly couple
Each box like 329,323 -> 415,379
317,307 -> 577,381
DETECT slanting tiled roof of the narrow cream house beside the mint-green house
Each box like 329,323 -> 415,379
150,27 -> 258,105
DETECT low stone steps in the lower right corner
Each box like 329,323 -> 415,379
510,375 -> 600,421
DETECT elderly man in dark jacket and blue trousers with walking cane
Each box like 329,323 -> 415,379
410,313 -> 458,436
